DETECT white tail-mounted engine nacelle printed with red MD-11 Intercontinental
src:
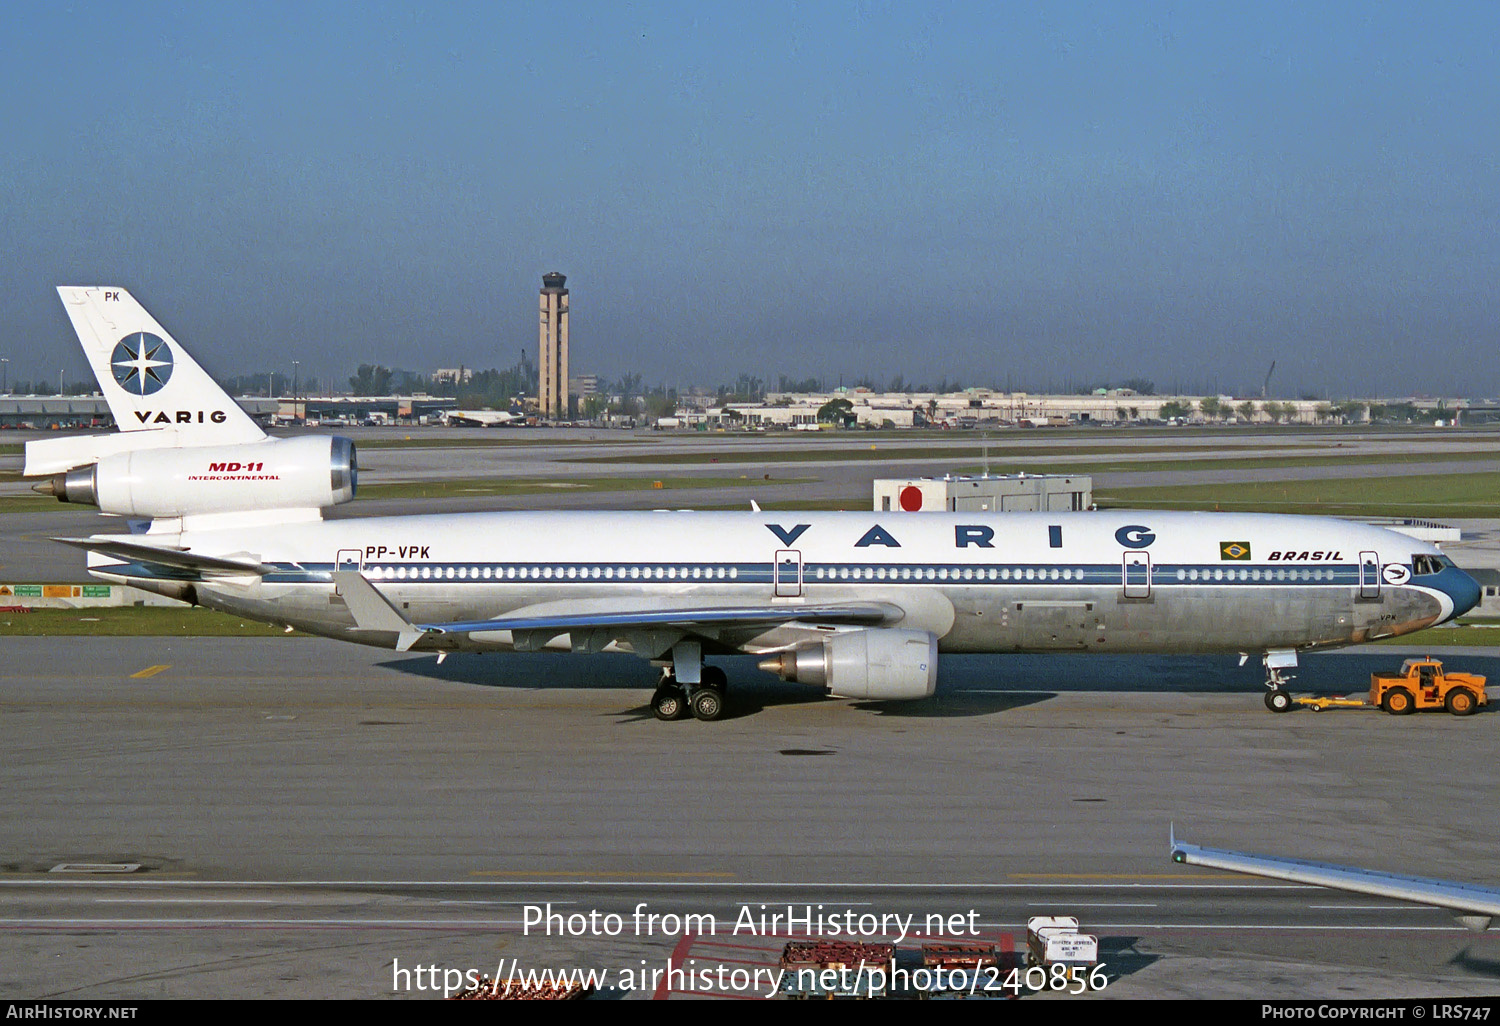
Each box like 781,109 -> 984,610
35,435 -> 359,518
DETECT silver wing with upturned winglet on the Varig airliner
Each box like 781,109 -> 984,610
333,570 -> 902,651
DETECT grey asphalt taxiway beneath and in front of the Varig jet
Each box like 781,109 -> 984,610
0,638 -> 1500,998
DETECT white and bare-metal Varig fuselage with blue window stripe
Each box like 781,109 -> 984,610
90,512 -> 1472,653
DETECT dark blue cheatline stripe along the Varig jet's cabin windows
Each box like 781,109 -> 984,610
249,561 -> 1391,588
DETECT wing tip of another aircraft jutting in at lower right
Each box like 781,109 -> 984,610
1172,836 -> 1500,930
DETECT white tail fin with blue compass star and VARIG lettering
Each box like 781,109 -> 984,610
57,285 -> 266,446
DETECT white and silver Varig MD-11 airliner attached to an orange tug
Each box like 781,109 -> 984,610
26,287 -> 1479,720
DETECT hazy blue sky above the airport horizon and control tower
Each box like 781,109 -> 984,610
0,3 -> 1500,396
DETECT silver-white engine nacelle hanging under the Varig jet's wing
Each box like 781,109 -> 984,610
761,629 -> 938,701
